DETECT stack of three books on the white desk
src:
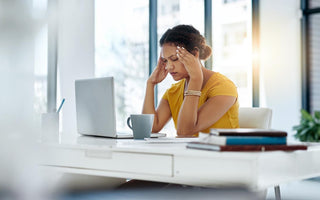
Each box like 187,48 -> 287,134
187,128 -> 307,151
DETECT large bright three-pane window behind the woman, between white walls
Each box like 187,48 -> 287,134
95,0 -> 252,135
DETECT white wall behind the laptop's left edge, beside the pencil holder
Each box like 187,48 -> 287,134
57,0 -> 94,134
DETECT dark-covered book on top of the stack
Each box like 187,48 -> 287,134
210,128 -> 288,137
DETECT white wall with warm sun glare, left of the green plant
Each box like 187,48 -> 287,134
260,0 -> 301,134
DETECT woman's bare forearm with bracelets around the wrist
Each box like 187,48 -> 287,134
177,76 -> 202,136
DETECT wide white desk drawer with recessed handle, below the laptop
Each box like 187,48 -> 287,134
42,148 -> 173,176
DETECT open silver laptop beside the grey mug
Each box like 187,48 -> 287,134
75,77 -> 166,138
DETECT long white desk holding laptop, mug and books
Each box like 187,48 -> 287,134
41,136 -> 320,190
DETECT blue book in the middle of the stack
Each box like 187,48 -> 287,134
199,134 -> 287,145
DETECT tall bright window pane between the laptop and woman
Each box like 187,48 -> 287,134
95,0 -> 149,131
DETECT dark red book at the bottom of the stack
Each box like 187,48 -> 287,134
187,142 -> 308,151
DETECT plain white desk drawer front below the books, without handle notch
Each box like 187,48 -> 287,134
174,156 -> 256,186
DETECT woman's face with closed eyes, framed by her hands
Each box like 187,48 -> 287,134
161,43 -> 189,81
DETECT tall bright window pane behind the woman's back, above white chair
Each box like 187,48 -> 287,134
212,0 -> 252,107
